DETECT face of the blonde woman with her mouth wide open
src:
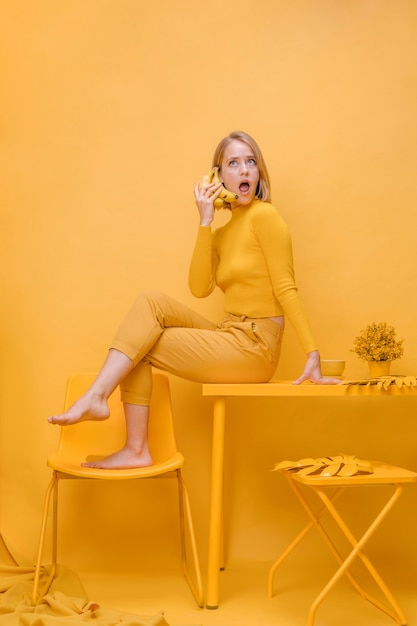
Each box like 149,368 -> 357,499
219,139 -> 259,208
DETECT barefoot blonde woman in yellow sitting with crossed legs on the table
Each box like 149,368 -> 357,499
49,132 -> 339,469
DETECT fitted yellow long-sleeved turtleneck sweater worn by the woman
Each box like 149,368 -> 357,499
189,199 -> 317,353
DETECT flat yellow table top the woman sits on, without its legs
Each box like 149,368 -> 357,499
202,380 -> 417,398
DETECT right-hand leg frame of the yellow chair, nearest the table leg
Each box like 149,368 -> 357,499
177,469 -> 204,607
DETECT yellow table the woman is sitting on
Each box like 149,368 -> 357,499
202,381 -> 417,609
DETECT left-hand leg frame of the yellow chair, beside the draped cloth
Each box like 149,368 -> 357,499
32,471 -> 58,606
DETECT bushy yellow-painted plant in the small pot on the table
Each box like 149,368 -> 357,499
351,322 -> 404,361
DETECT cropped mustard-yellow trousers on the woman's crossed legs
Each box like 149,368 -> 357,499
111,293 -> 282,405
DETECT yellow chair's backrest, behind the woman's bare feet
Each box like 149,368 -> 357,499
54,372 -> 177,463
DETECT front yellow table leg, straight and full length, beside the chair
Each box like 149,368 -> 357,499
206,397 -> 226,609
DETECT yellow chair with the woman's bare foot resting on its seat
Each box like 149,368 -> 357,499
32,373 -> 203,607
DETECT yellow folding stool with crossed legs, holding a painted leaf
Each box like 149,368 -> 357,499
268,462 -> 417,626
